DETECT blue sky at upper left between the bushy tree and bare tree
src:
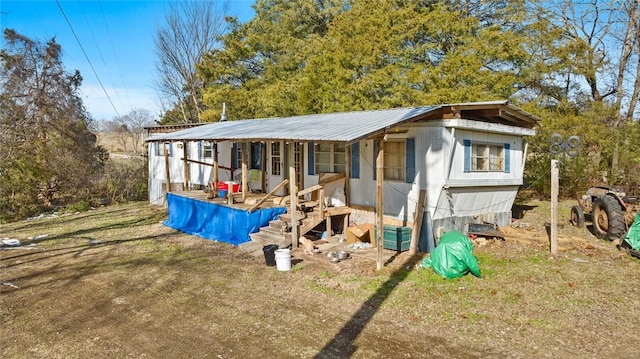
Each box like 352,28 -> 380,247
0,0 -> 255,120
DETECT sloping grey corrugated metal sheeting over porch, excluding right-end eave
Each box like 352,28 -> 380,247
147,106 -> 440,143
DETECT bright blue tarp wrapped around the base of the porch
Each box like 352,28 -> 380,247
164,193 -> 287,246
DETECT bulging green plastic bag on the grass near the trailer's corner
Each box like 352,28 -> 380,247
422,231 -> 481,279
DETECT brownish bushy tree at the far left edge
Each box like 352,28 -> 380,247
0,29 -> 105,215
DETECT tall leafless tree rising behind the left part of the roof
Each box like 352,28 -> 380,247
154,1 -> 228,123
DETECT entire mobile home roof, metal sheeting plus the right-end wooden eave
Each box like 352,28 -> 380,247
147,101 -> 538,144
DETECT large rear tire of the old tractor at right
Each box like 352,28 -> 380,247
592,195 -> 627,241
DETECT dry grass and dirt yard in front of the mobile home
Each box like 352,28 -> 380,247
0,202 -> 640,358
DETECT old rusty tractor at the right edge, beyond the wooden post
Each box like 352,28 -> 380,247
570,187 -> 640,241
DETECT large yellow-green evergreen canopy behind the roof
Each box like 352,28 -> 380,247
199,0 -> 531,118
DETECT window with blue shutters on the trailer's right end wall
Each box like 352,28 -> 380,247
464,140 -> 510,172
